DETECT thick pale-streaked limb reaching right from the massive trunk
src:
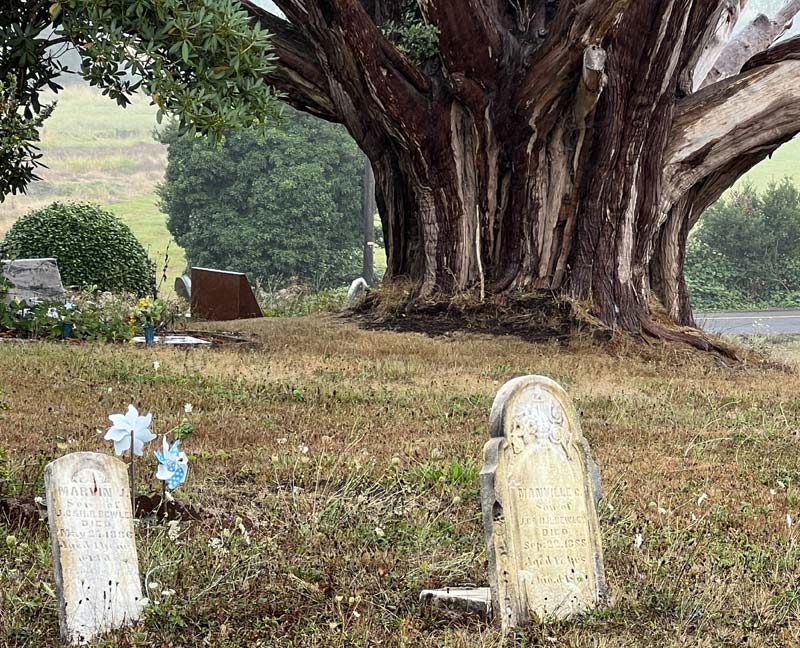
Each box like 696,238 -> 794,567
664,38 -> 800,206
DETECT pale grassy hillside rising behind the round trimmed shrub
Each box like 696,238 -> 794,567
0,85 -> 186,290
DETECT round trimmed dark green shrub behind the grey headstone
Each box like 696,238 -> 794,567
0,202 -> 156,296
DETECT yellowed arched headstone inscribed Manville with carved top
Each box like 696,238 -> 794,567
480,376 -> 606,628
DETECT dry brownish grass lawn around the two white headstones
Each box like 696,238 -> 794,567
0,317 -> 800,648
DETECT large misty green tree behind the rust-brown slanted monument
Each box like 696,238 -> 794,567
160,111 -> 363,288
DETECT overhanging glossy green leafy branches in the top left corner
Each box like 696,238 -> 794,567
0,0 -> 276,201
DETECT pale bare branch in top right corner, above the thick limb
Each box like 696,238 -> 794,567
701,0 -> 800,87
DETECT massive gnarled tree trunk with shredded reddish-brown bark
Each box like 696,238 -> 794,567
241,0 -> 800,344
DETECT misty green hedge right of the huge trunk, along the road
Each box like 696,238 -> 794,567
686,179 -> 800,310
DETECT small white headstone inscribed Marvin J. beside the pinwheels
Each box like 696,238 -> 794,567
45,452 -> 144,644
